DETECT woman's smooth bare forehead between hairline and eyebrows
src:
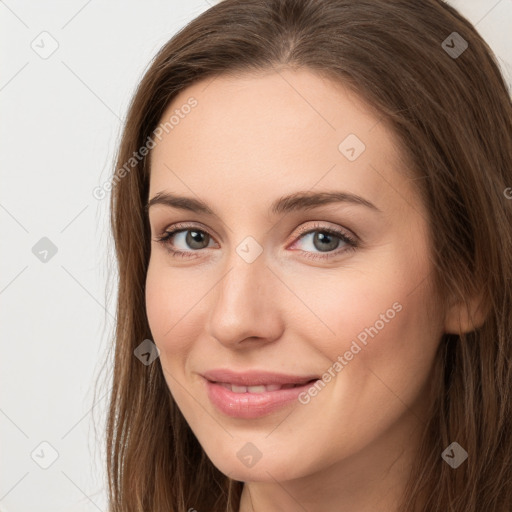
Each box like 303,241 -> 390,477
150,70 -> 414,214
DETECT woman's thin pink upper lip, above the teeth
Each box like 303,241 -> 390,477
202,369 -> 319,386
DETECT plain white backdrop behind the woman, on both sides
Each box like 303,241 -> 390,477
0,0 -> 512,512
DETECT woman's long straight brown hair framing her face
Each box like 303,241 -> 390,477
100,0 -> 512,512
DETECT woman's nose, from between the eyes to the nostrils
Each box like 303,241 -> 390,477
207,246 -> 285,349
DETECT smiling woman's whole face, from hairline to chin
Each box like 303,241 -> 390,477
146,70 -> 443,482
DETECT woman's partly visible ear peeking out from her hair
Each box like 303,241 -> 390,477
444,293 -> 489,334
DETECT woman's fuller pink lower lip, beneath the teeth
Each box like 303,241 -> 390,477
205,379 -> 314,419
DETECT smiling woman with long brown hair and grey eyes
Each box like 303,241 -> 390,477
102,0 -> 512,512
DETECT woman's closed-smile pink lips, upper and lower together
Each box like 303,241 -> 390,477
203,370 -> 318,419
